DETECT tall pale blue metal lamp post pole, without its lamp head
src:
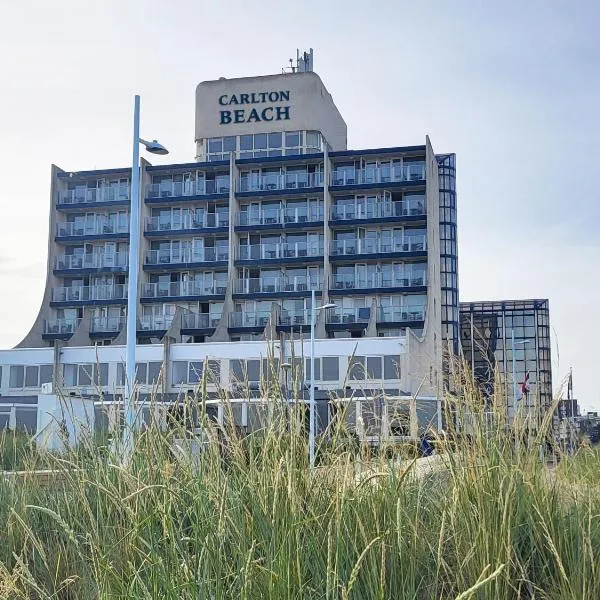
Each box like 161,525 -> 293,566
123,95 -> 140,460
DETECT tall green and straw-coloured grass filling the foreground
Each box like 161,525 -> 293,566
0,360 -> 600,600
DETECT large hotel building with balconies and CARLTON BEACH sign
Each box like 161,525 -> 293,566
0,57 -> 459,435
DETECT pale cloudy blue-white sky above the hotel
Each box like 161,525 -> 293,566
0,0 -> 600,409
